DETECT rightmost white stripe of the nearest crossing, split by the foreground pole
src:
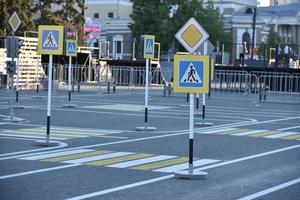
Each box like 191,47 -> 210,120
153,159 -> 220,173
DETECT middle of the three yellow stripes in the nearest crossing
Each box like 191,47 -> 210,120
85,153 -> 153,166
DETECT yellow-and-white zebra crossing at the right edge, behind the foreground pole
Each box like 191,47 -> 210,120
200,128 -> 300,140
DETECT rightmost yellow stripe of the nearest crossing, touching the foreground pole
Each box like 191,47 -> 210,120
130,157 -> 189,170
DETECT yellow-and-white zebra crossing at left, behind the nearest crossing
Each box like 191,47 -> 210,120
0,127 -> 122,140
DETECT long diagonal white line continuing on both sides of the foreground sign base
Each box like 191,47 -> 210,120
65,145 -> 300,200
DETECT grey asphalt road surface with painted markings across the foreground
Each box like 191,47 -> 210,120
0,90 -> 300,200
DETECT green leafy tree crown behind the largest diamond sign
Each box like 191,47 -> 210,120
130,0 -> 231,51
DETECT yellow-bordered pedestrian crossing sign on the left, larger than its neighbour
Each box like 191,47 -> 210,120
38,25 -> 64,55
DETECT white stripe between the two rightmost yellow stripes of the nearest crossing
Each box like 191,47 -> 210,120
107,155 -> 177,168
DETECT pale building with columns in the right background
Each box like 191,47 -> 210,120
230,3 -> 300,63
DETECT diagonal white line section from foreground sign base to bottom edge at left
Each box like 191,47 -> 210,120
65,174 -> 174,200
